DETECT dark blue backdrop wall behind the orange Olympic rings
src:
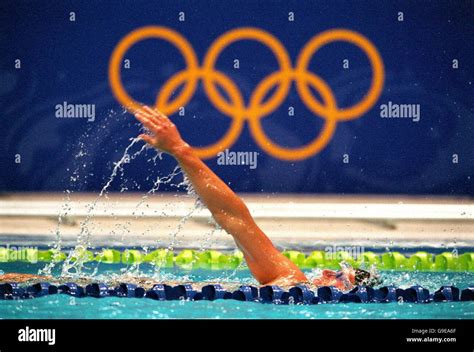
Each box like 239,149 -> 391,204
0,0 -> 474,196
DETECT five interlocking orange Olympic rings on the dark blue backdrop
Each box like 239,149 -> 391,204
109,26 -> 384,160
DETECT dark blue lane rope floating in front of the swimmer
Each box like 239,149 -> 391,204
0,282 -> 474,304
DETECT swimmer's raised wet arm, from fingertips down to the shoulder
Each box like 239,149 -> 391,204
135,107 -> 306,284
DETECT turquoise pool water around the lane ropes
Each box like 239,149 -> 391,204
0,262 -> 474,319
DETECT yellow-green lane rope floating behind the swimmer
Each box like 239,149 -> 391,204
0,247 -> 474,272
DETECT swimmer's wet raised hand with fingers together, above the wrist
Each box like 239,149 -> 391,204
135,106 -> 189,155
